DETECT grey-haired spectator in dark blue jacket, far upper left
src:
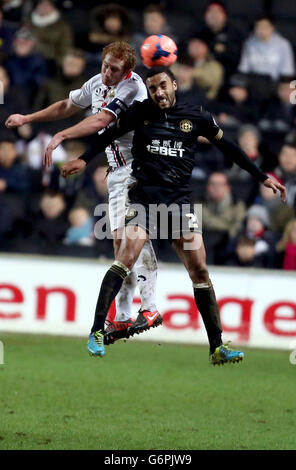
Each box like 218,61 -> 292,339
5,27 -> 48,103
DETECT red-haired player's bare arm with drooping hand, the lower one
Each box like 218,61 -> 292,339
43,111 -> 115,167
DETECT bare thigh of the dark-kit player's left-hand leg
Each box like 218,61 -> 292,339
116,225 -> 148,269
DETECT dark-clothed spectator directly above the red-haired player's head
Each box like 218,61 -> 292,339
88,3 -> 131,53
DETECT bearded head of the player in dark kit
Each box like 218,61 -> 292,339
146,72 -> 177,109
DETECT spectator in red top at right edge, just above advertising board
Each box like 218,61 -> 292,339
276,219 -> 296,271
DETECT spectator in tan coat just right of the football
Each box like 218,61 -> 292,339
188,38 -> 224,100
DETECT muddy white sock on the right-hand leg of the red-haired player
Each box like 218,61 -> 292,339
134,240 -> 157,312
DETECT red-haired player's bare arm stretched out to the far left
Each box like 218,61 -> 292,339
5,99 -> 81,129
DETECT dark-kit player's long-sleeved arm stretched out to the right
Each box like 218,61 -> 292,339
212,137 -> 286,201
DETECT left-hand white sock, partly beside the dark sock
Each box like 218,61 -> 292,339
114,268 -> 137,321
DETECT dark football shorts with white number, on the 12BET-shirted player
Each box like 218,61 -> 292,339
125,184 -> 202,242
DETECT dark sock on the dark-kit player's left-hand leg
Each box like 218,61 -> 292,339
91,264 -> 128,333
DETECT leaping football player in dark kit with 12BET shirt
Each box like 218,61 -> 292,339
62,68 -> 286,365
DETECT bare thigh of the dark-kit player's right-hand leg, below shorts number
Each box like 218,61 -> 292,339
172,233 -> 208,282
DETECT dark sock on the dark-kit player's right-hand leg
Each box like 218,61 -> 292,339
194,281 -> 222,354
